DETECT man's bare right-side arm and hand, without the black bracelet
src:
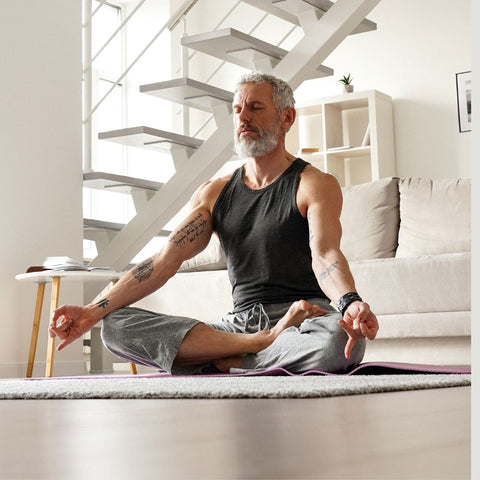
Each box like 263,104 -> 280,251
298,169 -> 378,358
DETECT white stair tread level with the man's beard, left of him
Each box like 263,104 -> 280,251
98,126 -> 203,151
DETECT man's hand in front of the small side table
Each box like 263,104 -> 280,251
48,305 -> 100,351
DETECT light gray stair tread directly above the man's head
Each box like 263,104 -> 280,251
182,28 -> 333,77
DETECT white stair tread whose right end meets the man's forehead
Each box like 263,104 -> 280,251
140,78 -> 233,112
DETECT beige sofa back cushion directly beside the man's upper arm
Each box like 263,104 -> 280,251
340,177 -> 399,262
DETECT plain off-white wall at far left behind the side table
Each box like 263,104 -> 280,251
0,0 -> 83,377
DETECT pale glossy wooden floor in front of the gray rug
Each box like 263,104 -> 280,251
0,387 -> 470,480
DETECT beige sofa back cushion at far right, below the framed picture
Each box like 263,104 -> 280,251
396,178 -> 470,257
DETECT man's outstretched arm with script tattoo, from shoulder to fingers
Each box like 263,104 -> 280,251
49,178 -> 222,350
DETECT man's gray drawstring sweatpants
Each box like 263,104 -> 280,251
102,299 -> 365,374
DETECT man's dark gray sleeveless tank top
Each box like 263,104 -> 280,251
213,159 -> 327,312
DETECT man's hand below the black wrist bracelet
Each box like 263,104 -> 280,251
338,301 -> 378,358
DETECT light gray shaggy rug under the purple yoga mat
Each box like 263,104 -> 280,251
0,374 -> 470,400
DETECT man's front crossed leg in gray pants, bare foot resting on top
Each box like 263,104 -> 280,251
101,300 -> 326,372
